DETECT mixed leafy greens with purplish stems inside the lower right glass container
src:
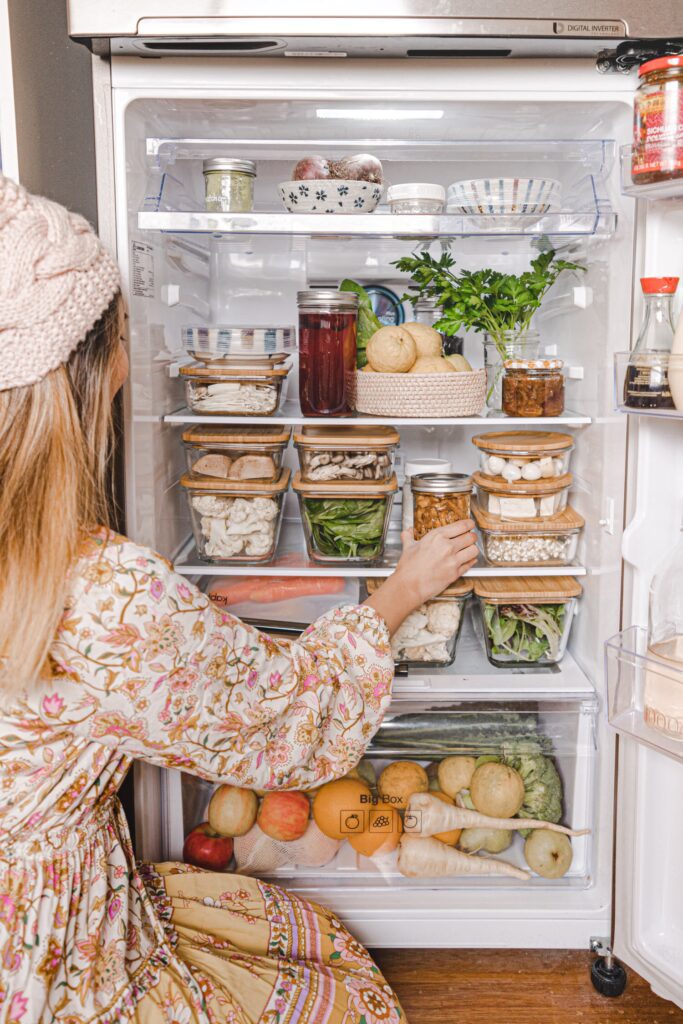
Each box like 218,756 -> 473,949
483,604 -> 565,662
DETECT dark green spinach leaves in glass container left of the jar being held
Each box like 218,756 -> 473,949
303,498 -> 386,558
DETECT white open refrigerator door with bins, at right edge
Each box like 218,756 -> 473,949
605,186 -> 683,1006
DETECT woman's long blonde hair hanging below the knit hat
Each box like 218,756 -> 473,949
0,295 -> 121,695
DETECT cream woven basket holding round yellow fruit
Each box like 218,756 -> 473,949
355,370 -> 486,419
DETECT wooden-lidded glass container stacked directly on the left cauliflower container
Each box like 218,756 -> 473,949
182,424 -> 292,480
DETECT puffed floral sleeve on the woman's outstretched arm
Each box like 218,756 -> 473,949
36,535 -> 393,788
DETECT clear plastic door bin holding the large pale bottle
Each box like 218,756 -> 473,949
605,626 -> 683,761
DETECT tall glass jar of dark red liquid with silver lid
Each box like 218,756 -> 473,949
297,288 -> 358,416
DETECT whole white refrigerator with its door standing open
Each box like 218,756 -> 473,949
69,0 -> 683,1006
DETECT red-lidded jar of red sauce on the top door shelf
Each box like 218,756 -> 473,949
631,56 -> 683,184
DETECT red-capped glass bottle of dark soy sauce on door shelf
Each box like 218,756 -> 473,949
624,278 -> 679,409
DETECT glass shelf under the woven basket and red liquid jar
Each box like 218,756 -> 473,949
164,400 -> 591,427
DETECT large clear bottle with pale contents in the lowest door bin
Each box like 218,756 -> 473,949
644,536 -> 683,740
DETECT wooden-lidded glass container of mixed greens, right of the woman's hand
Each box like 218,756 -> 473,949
474,577 -> 582,669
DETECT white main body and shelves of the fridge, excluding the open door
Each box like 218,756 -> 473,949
98,57 -> 651,947
